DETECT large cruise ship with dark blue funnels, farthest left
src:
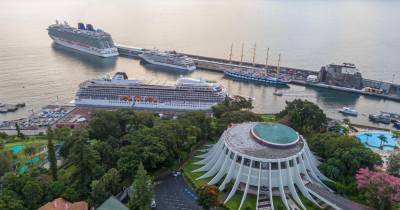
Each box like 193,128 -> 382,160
47,21 -> 118,57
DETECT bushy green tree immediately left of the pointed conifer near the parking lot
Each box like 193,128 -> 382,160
90,168 -> 122,206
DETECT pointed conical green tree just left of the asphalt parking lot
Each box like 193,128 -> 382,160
128,163 -> 154,210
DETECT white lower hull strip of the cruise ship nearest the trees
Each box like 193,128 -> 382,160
73,99 -> 217,111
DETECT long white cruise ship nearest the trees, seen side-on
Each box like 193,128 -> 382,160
74,72 -> 227,111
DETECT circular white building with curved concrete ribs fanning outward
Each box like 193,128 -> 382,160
194,122 -> 332,209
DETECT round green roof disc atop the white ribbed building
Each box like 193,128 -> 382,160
252,123 -> 299,146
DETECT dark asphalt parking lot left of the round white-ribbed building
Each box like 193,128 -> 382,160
155,174 -> 200,210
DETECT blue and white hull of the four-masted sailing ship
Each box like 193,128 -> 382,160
224,69 -> 290,86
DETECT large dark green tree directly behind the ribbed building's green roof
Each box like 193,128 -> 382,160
278,99 -> 327,134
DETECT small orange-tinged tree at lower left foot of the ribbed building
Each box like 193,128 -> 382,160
197,185 -> 219,210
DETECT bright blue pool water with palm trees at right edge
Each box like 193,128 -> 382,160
357,131 -> 399,151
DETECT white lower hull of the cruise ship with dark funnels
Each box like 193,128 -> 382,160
50,36 -> 118,58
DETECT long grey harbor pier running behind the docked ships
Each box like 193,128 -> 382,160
116,44 -> 400,101
